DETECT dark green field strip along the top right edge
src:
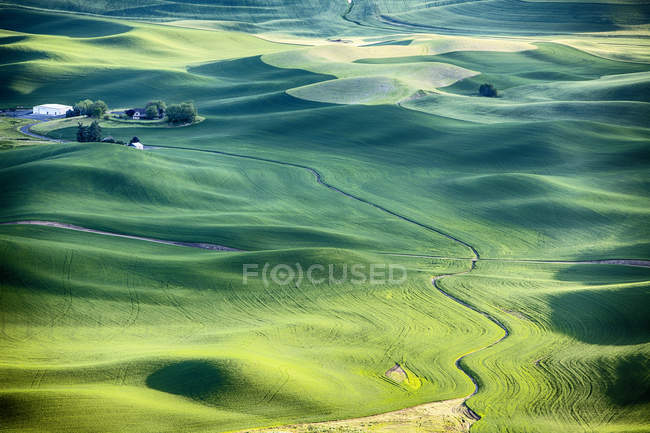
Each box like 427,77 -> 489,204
349,0 -> 648,35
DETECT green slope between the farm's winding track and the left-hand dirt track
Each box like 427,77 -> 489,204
0,144 -> 467,256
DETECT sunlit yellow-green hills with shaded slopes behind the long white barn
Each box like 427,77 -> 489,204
0,7 -> 296,106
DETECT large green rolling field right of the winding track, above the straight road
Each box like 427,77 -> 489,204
63,105 -> 647,258
